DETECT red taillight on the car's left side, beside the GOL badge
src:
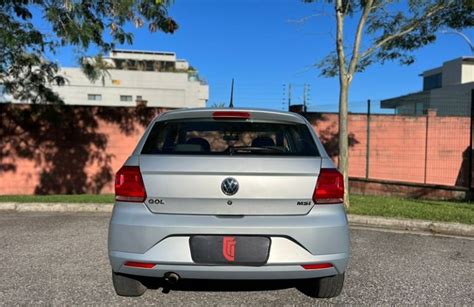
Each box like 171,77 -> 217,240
115,166 -> 146,202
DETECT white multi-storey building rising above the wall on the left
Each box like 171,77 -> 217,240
1,50 -> 209,108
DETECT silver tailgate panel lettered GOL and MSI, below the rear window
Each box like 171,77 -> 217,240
140,155 -> 321,215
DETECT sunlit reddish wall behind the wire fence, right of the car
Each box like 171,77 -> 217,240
306,111 -> 470,186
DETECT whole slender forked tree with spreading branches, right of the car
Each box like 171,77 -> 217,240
303,0 -> 474,207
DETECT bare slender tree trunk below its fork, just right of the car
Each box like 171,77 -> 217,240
338,78 -> 350,208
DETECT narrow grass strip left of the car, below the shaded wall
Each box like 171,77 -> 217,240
0,194 -> 114,204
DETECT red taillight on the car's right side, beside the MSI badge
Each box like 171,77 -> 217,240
313,168 -> 344,204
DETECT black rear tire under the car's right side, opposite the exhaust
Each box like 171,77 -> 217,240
299,273 -> 344,298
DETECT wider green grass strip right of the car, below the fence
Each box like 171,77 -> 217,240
348,195 -> 474,224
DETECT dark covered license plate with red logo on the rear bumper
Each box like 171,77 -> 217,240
189,236 -> 270,265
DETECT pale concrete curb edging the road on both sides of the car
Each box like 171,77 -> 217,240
0,202 -> 474,237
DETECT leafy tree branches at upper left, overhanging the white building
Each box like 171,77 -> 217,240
0,0 -> 178,103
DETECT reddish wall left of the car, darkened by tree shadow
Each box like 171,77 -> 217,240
0,104 -> 168,195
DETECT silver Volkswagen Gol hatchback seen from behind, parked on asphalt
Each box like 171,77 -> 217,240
108,109 -> 349,297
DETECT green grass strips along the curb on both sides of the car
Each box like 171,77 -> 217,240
0,194 -> 474,224
